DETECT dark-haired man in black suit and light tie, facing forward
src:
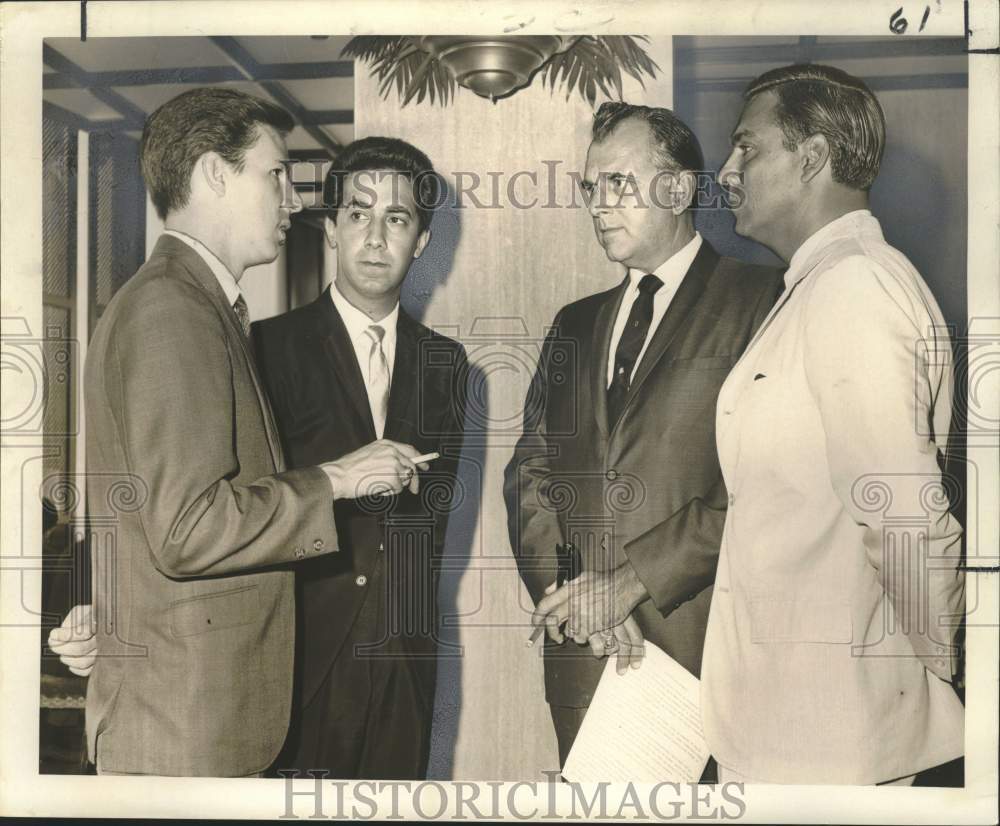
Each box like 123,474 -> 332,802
254,137 -> 465,779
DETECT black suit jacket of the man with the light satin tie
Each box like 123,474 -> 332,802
253,292 -> 466,704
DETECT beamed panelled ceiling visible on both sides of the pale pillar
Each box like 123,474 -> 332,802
42,36 -> 967,157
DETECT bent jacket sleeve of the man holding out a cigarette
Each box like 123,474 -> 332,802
104,281 -> 337,577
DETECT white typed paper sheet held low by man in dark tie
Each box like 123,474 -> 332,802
562,641 -> 709,783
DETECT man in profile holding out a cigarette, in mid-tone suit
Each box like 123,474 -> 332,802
75,89 -> 426,776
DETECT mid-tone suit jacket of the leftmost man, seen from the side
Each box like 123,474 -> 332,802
85,236 -> 337,776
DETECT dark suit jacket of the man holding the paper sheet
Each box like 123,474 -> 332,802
504,242 -> 778,707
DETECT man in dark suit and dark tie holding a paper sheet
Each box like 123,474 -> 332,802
505,103 -> 779,763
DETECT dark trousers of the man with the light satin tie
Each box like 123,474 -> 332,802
272,566 -> 436,780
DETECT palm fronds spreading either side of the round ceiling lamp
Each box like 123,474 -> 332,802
341,35 -> 660,106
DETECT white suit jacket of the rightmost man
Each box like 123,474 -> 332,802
702,211 -> 964,784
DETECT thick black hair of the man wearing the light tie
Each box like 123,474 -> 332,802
323,136 -> 441,232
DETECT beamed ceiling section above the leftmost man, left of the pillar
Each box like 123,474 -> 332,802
42,36 -> 354,157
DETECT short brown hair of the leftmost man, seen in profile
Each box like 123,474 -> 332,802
139,88 -> 295,219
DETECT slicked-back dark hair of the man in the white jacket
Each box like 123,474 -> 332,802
743,63 -> 885,191
